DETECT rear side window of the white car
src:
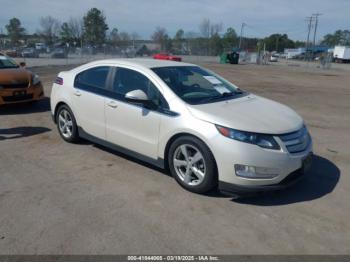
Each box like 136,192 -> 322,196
74,66 -> 110,91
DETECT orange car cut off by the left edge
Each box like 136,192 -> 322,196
0,53 -> 44,105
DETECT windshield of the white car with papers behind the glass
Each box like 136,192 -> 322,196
152,66 -> 246,104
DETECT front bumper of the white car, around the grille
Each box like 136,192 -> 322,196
206,130 -> 312,192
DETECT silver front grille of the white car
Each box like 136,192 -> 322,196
279,127 -> 311,154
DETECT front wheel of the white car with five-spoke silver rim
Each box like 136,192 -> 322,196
168,136 -> 218,194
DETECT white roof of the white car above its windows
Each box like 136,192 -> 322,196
87,58 -> 194,68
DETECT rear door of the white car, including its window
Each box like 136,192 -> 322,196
73,66 -> 111,139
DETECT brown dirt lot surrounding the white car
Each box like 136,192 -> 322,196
0,64 -> 350,254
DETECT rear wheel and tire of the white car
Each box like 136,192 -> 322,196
56,105 -> 79,143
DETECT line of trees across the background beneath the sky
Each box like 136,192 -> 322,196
1,8 -> 350,55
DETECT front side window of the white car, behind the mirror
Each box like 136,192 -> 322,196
112,68 -> 166,106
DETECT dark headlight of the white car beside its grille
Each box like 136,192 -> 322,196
215,125 -> 280,150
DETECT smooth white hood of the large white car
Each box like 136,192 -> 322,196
188,94 -> 303,134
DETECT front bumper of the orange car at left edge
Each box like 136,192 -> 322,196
0,83 -> 44,105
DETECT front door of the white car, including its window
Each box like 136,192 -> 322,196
105,67 -> 161,159
